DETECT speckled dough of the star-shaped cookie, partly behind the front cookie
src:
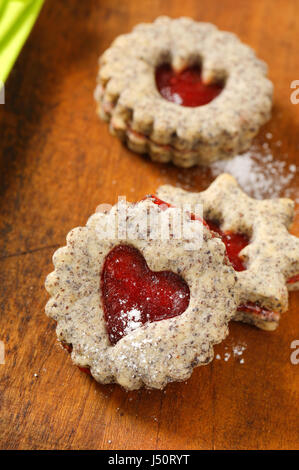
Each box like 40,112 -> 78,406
157,174 -> 299,330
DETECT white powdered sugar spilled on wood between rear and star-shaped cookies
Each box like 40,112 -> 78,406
211,143 -> 299,202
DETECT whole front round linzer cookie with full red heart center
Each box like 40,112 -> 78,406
46,199 -> 239,390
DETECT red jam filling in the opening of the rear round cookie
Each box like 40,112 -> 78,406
156,64 -> 223,107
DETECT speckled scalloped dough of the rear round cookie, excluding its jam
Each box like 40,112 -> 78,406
95,17 -> 273,167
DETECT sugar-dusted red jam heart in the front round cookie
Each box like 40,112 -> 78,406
101,245 -> 190,344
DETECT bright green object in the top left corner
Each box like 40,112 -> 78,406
0,0 -> 44,83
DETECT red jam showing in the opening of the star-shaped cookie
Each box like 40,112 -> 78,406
206,220 -> 249,271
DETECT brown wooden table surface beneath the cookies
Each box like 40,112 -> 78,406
0,0 -> 299,449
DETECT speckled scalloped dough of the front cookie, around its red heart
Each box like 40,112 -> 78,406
46,199 -> 239,390
